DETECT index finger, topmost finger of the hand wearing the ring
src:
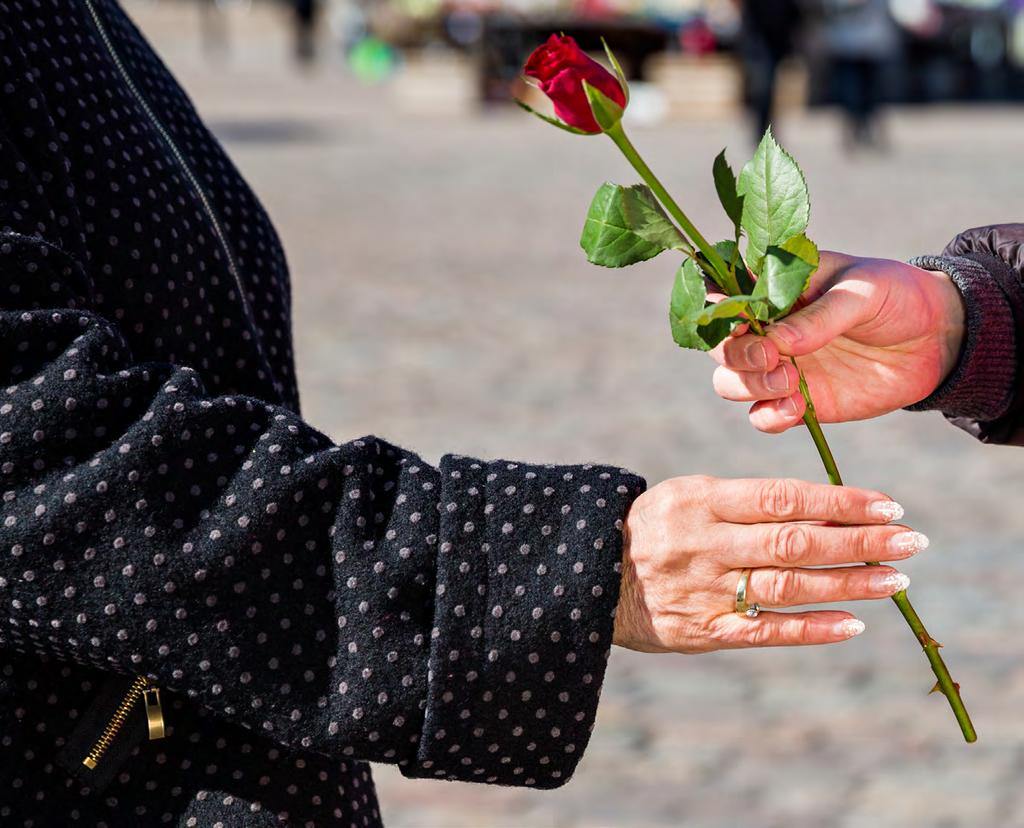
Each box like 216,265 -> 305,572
705,479 -> 903,525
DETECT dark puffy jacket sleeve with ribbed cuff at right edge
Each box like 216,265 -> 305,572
909,224 -> 1024,445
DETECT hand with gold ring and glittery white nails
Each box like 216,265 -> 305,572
614,477 -> 928,653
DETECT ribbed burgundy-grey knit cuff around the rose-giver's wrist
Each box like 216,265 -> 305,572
907,256 -> 1017,422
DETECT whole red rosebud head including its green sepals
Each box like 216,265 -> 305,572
518,35 -> 629,135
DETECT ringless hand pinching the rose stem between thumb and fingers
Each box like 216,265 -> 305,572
712,253 -> 964,432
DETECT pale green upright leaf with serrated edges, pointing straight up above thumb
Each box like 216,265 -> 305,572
737,129 -> 810,275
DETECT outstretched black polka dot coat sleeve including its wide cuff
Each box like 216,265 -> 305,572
0,153 -> 643,787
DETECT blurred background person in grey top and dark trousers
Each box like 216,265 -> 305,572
824,0 -> 900,147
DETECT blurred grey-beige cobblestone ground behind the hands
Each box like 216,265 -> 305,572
129,2 -> 1024,828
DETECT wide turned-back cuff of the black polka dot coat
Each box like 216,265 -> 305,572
402,456 -> 645,788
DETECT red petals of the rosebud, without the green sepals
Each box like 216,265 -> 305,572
523,35 -> 626,133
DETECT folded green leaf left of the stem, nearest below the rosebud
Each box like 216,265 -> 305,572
580,183 -> 686,267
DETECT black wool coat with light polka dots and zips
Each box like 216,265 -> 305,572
0,0 -> 643,828
